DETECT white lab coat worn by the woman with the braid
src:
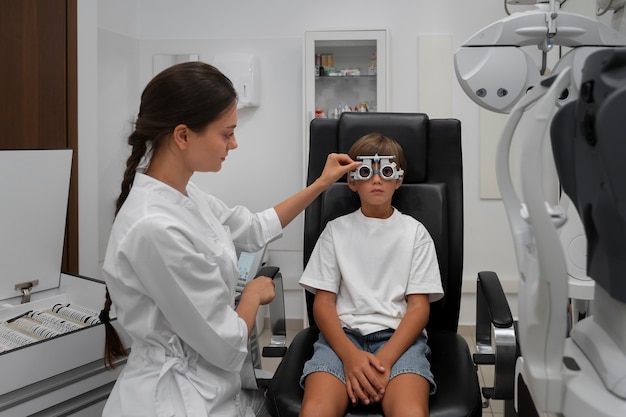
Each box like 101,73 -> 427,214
103,173 -> 282,417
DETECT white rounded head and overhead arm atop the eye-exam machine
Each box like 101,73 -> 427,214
454,0 -> 626,113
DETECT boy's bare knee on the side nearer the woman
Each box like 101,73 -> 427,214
300,372 -> 348,417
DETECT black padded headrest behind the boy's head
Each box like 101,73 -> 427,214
337,113 -> 428,184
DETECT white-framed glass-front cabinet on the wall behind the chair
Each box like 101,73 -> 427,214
304,29 -> 387,161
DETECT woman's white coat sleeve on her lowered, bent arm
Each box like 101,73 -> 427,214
119,217 -> 248,372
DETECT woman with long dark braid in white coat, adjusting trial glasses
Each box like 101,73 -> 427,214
100,62 -> 357,417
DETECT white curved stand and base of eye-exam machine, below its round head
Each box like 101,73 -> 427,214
497,48 -> 626,417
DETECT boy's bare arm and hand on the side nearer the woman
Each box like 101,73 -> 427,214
313,290 -> 386,404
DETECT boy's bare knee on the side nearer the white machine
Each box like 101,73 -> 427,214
382,373 -> 430,417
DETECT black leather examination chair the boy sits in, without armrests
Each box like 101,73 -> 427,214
266,113 -> 482,417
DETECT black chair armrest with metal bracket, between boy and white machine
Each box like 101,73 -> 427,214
473,271 -> 519,400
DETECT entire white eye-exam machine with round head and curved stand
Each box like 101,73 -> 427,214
455,0 -> 626,417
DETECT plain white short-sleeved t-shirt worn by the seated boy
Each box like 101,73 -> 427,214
300,209 -> 443,335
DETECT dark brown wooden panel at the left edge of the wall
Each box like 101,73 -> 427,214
0,0 -> 78,273
